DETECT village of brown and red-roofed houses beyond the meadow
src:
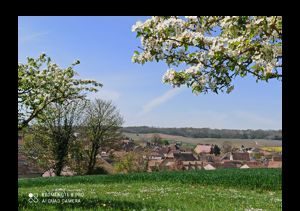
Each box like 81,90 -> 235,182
18,134 -> 282,177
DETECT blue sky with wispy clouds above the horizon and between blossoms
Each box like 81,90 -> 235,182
18,16 -> 282,129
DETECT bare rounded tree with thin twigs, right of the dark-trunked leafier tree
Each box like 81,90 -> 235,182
85,99 -> 124,174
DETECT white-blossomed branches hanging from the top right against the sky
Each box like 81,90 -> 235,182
132,16 -> 282,94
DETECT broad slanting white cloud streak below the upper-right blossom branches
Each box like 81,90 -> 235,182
138,88 -> 181,116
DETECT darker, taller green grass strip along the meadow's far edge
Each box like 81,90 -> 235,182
18,169 -> 282,190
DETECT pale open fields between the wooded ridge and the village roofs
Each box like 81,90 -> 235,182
123,133 -> 282,147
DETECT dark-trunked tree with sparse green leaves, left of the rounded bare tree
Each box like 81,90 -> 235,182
23,100 -> 85,176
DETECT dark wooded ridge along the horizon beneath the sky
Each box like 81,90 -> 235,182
122,126 -> 282,140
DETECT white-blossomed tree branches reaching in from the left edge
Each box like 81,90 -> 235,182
18,54 -> 102,130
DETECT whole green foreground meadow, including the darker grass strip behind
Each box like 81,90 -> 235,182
19,169 -> 282,211
